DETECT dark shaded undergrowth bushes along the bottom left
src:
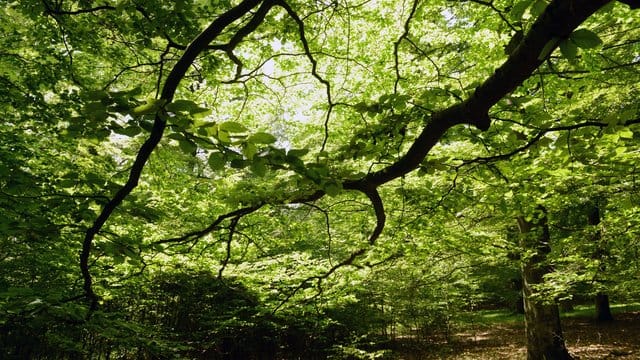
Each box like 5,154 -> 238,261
0,272 -> 386,360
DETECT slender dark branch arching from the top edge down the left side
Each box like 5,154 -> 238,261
80,0 -> 260,316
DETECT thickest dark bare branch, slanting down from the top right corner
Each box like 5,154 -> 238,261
345,0 -> 610,188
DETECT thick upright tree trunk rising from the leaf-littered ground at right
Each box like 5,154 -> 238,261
518,208 -> 573,360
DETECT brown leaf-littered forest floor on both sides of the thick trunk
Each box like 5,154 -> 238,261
392,311 -> 640,360
